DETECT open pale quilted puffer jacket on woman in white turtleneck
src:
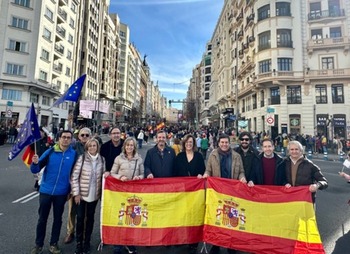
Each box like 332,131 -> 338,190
71,152 -> 105,200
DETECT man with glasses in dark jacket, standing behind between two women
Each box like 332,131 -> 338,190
100,127 -> 124,172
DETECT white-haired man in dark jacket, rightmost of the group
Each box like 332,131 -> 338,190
286,140 -> 328,203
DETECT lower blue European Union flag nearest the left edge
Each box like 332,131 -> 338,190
8,103 -> 41,161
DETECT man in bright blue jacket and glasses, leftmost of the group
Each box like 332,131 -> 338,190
30,130 -> 77,254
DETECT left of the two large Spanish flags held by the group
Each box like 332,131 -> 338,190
101,177 -> 205,246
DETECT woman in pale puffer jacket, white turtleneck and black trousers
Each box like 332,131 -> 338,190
71,138 -> 105,254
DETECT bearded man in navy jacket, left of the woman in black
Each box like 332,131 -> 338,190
144,131 -> 176,178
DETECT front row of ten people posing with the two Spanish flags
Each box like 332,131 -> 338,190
31,127 -> 328,254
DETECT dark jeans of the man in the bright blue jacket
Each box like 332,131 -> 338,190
35,193 -> 67,247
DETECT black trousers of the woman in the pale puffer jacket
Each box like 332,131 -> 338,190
76,200 -> 98,245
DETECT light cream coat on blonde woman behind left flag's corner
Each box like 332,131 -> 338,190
111,153 -> 144,180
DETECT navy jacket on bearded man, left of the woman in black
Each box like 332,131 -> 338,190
144,145 -> 176,178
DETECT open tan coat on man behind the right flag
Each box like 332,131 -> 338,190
205,149 -> 244,180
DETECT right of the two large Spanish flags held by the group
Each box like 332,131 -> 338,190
204,177 -> 325,254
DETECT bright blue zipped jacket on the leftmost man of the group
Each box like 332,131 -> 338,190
30,144 -> 77,195
